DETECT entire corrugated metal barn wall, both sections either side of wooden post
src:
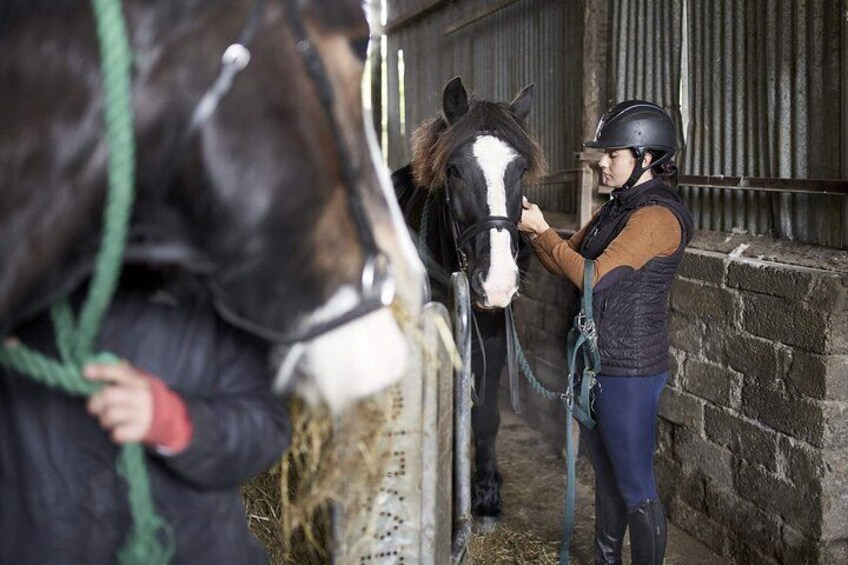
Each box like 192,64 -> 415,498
386,0 -> 848,247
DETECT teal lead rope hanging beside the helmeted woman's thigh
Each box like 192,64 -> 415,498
512,259 -> 601,565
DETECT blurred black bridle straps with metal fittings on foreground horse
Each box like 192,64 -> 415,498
188,0 -> 396,344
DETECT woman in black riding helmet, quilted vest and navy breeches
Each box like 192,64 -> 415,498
518,100 -> 693,565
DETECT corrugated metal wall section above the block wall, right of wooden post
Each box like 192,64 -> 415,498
609,0 -> 848,246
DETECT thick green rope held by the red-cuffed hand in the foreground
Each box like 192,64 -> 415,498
0,0 -> 174,565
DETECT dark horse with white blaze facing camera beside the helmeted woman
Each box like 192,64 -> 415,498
392,77 -> 544,530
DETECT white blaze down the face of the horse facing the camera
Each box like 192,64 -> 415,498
474,135 -> 518,308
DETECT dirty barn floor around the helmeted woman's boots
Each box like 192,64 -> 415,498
484,407 -> 728,565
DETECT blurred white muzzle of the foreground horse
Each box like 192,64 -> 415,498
278,287 -> 408,412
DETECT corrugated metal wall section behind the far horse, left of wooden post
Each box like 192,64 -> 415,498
386,0 -> 583,212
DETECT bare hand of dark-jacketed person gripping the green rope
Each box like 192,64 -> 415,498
85,362 -> 153,444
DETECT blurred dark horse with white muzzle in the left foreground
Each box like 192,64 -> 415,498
0,0 -> 424,406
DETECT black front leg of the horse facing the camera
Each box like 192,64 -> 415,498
471,315 -> 506,532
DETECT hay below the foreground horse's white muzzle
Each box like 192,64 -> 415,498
242,394 -> 389,565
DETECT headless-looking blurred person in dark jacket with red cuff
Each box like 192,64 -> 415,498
0,272 -> 290,565
